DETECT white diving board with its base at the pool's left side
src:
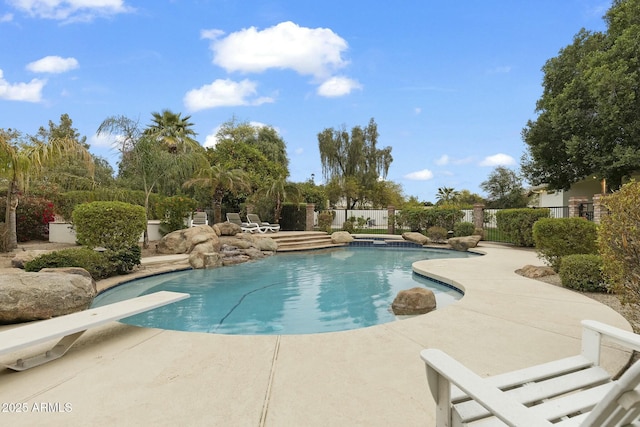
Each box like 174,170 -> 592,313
0,291 -> 190,371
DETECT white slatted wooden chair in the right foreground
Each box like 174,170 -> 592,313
420,320 -> 640,427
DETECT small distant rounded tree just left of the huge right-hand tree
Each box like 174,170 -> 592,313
480,166 -> 528,209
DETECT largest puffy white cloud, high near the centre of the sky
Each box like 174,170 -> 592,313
201,21 -> 348,80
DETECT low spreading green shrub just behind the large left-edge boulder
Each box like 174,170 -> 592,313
24,245 -> 141,280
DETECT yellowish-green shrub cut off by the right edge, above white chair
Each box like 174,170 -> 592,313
598,181 -> 640,309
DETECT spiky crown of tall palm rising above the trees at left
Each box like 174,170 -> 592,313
144,110 -> 202,153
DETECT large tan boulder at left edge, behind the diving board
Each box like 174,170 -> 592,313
0,268 -> 96,323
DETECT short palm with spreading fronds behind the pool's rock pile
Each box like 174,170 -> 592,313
184,165 -> 251,223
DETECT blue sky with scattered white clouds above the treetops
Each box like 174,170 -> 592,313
0,0 -> 611,201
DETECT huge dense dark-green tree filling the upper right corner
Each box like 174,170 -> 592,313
521,0 -> 640,189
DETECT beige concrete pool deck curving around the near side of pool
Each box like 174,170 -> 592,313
0,242 -> 631,426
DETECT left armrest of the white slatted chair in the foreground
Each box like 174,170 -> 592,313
420,349 -> 553,427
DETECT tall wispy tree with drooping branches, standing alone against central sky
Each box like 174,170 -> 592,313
318,119 -> 393,209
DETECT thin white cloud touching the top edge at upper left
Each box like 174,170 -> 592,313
8,0 -> 134,22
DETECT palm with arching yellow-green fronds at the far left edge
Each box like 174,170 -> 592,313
0,129 -> 94,249
